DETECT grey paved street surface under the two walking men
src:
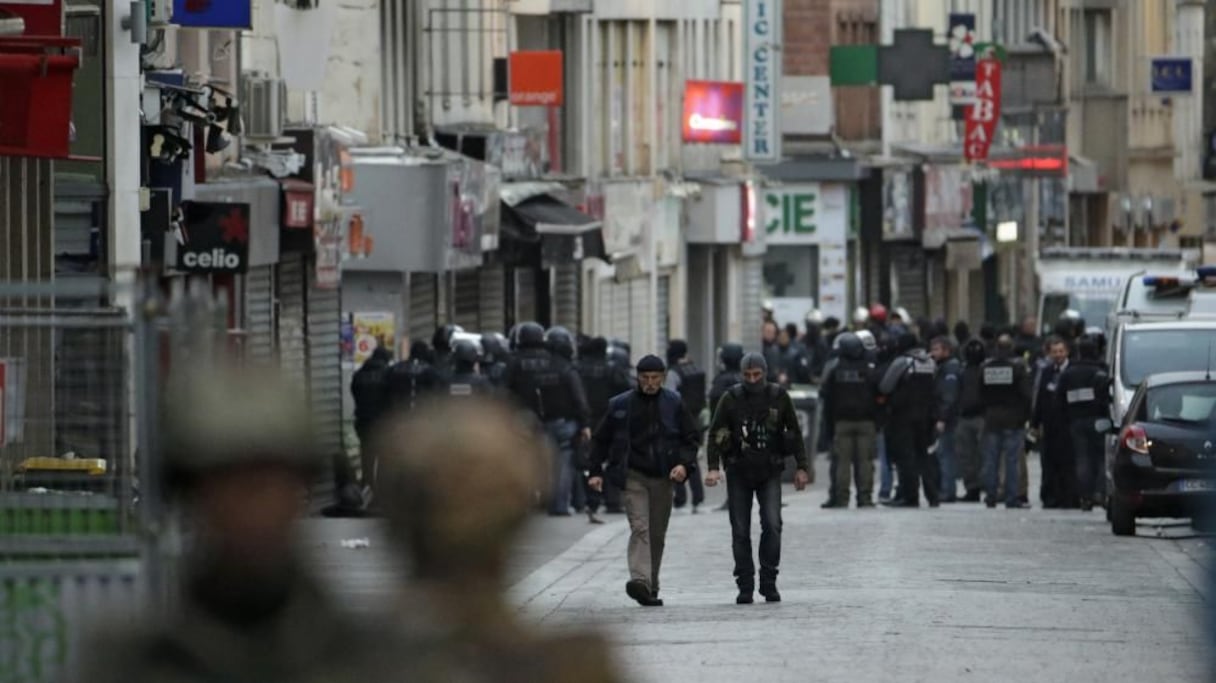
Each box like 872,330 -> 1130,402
296,459 -> 1212,683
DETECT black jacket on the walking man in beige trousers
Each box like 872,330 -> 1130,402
590,389 -> 700,487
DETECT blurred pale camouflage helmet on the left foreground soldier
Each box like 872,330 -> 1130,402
162,365 -> 323,487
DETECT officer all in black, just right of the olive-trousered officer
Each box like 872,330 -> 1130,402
878,332 -> 941,508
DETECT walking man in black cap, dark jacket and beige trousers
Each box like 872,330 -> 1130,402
589,356 -> 700,606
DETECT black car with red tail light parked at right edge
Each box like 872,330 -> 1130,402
1107,372 -> 1216,536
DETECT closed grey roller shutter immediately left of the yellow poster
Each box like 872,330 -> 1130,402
308,269 -> 343,461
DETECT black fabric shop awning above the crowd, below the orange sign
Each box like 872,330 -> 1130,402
500,193 -> 612,266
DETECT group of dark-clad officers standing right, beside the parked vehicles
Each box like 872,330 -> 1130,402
807,305 -> 1110,510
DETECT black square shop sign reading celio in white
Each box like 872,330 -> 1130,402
176,202 -> 249,273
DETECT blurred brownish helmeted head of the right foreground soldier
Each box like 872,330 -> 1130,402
372,399 -> 552,582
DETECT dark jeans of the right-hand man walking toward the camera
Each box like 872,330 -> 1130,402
726,469 -> 781,591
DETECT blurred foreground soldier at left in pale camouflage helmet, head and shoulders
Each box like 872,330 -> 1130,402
77,359 -> 393,683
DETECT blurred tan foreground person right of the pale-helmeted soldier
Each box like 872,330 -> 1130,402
376,397 -> 627,683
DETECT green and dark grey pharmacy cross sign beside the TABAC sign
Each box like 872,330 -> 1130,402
831,28 -> 950,101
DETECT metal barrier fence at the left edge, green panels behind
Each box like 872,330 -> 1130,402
0,277 -> 226,683
